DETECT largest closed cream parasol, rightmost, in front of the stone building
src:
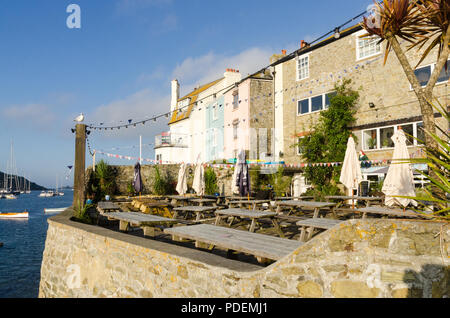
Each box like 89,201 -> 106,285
382,129 -> 417,207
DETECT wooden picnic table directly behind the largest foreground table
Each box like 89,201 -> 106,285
214,209 -> 284,237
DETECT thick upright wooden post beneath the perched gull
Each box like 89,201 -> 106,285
73,124 -> 86,209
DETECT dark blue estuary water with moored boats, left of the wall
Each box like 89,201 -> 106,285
0,191 -> 73,298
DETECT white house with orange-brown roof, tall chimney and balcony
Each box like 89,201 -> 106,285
154,69 -> 241,164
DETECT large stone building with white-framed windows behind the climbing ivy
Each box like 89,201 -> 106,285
273,25 -> 450,179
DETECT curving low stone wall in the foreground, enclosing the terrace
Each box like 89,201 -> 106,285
39,210 -> 450,298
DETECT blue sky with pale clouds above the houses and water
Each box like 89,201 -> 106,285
0,0 -> 372,187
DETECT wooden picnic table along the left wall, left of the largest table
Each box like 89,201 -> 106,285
108,212 -> 178,237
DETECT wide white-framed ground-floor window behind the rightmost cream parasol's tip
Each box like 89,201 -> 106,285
362,122 -> 425,150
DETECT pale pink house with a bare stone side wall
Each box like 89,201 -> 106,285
224,71 -> 273,161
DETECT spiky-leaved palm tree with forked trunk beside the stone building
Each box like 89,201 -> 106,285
362,0 -> 450,149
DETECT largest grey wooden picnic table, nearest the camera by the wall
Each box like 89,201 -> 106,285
164,224 -> 304,262
